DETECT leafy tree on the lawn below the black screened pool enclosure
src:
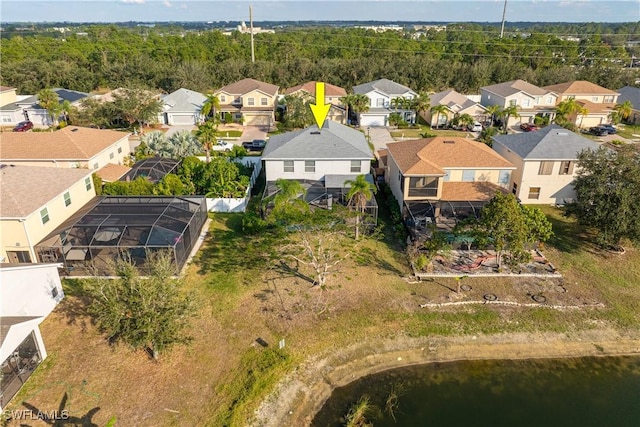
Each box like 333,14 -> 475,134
89,252 -> 193,360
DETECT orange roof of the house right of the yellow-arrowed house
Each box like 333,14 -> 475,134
387,136 -> 513,175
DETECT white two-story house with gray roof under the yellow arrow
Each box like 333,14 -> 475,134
262,120 -> 375,214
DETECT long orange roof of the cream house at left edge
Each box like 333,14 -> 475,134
0,126 -> 129,162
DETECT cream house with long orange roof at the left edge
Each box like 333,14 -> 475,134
0,126 -> 131,169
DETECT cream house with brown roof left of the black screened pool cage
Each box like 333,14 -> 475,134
0,163 -> 96,263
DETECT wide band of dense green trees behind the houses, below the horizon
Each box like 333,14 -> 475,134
0,24 -> 640,93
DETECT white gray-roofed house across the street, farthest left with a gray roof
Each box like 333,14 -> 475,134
158,88 -> 207,125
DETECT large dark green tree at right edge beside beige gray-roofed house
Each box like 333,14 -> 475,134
566,146 -> 640,248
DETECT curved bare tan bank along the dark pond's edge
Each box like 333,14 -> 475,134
252,330 -> 640,427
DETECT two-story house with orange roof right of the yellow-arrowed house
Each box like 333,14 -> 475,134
385,137 -> 514,224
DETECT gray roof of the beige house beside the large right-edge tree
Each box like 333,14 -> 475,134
492,124 -> 600,160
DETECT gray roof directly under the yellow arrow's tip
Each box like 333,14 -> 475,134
262,120 -> 373,160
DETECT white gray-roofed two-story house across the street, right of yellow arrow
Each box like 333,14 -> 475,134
353,79 -> 418,126
